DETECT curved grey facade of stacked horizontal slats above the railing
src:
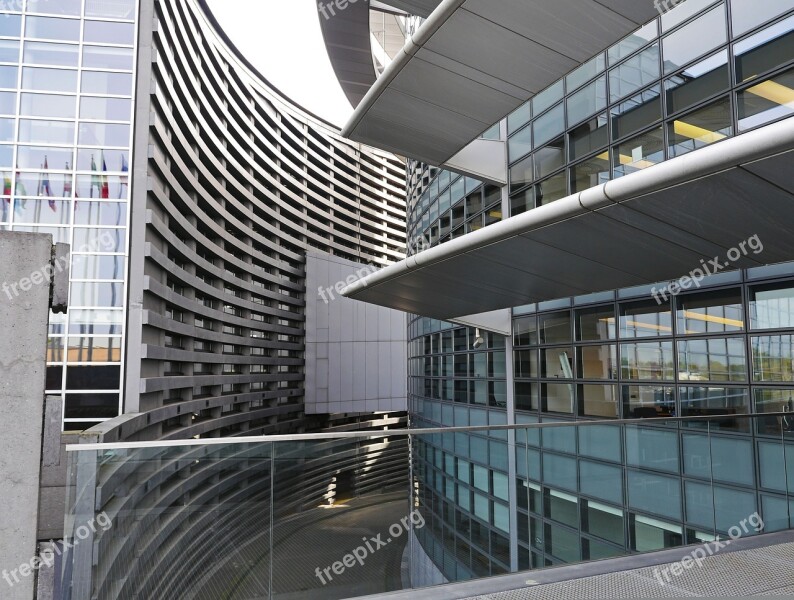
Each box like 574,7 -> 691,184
124,2 -> 405,439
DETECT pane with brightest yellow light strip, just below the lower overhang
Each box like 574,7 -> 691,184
676,290 -> 744,334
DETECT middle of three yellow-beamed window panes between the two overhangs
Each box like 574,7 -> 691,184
667,98 -> 733,158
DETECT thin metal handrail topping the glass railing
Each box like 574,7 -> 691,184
66,411 -> 794,452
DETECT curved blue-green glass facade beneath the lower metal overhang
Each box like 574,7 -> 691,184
409,263 -> 794,580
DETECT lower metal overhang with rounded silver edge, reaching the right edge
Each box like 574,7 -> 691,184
343,118 -> 794,319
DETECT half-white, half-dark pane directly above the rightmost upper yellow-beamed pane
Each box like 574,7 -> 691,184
733,17 -> 794,83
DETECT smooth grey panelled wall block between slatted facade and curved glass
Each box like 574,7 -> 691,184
306,251 -> 408,414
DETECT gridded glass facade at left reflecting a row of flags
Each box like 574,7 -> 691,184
0,0 -> 137,425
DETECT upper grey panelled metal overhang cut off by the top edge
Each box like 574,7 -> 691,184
342,0 -> 658,165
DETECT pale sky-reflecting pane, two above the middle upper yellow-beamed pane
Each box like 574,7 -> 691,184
663,4 -> 728,73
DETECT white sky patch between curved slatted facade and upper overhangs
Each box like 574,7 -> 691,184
208,0 -> 353,127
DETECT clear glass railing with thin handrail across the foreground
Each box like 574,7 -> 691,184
61,412 -> 794,600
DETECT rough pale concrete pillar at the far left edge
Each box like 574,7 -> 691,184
0,232 -> 52,600
